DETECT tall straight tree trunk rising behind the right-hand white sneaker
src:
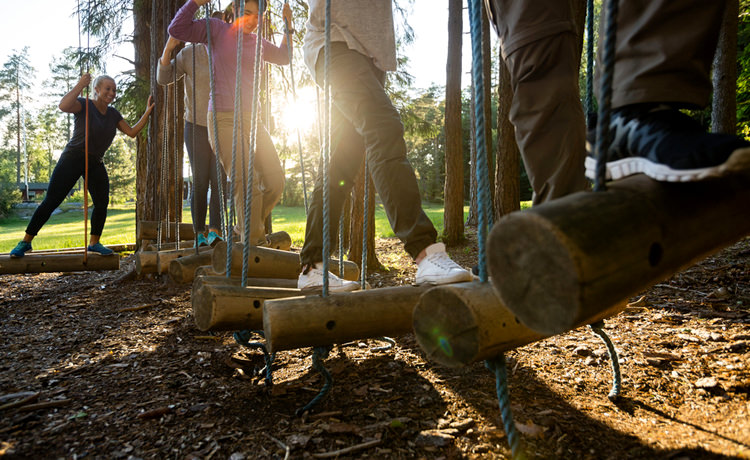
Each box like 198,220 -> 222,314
443,0 -> 464,244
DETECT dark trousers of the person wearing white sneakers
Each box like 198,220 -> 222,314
300,42 -> 437,265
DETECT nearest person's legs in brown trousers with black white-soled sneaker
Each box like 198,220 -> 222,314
485,0 -> 750,204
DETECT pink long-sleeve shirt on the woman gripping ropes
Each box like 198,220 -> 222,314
168,0 -> 289,112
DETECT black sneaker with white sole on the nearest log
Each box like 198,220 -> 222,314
586,105 -> 750,182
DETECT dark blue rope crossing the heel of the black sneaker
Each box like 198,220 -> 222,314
594,0 -> 619,192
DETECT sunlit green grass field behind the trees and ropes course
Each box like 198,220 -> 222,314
0,202 -> 530,253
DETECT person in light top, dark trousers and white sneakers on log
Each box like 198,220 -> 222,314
297,0 -> 473,292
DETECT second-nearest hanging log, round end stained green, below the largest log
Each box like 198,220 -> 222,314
413,281 -> 625,367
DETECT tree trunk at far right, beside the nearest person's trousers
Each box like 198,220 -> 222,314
711,0 -> 739,134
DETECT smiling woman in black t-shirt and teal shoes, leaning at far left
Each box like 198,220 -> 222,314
10,73 -> 154,257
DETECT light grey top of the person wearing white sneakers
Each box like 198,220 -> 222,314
302,0 -> 396,80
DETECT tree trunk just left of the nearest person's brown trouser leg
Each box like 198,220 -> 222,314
495,59 -> 521,221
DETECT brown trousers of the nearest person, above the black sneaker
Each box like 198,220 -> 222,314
486,0 -> 725,204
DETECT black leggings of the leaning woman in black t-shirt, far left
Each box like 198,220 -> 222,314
26,152 -> 109,236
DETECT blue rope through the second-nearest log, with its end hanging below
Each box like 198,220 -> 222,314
469,0 -> 521,458
